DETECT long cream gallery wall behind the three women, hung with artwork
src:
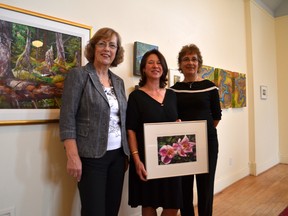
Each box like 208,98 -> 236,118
0,0 -> 288,216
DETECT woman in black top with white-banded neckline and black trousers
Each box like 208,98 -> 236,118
171,44 -> 221,216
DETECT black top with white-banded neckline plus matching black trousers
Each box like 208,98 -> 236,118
171,80 -> 222,216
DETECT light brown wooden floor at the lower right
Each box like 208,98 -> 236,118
209,164 -> 288,216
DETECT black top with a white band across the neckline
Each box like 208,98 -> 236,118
171,80 -> 222,135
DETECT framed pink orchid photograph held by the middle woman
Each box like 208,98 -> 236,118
144,120 -> 208,179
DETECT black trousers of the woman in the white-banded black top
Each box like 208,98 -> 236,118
180,140 -> 218,216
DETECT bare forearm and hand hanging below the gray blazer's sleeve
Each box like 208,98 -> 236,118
64,139 -> 82,182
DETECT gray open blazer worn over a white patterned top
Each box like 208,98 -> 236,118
60,63 -> 129,158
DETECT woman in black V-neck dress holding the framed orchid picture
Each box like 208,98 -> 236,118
126,50 -> 182,216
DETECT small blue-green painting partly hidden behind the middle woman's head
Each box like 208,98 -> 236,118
133,41 -> 158,76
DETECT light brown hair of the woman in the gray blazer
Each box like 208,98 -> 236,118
84,28 -> 124,67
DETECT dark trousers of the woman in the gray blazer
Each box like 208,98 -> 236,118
78,148 -> 125,216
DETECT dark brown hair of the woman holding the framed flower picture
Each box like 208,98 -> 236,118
139,49 -> 168,88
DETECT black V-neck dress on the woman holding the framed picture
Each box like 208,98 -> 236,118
126,89 -> 182,209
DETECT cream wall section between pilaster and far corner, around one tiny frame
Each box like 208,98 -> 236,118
249,0 -> 279,174
